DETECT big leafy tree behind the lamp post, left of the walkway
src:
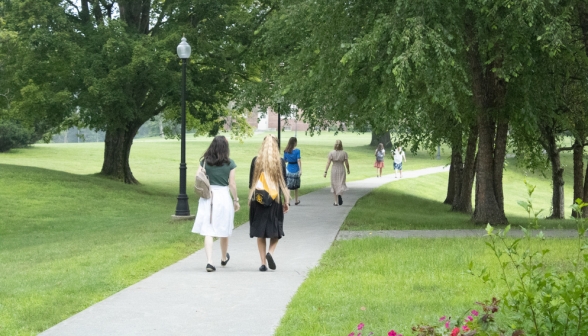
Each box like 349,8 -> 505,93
1,0 -> 271,183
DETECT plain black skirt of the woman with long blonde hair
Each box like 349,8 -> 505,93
249,201 -> 284,238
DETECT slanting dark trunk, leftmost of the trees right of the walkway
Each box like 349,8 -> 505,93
451,126 -> 478,214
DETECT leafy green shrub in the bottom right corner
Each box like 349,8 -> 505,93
478,182 -> 588,336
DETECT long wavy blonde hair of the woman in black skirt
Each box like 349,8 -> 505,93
249,134 -> 290,203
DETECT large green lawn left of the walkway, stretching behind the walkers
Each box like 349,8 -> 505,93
0,132 -> 443,335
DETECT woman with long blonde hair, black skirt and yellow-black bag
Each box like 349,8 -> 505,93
248,134 -> 290,272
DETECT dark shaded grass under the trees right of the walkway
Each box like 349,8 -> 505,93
341,187 -> 576,231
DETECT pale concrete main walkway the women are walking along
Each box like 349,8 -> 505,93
42,167 -> 448,336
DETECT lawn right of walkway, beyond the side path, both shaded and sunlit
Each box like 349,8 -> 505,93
341,155 -> 576,231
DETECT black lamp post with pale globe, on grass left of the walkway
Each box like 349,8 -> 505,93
175,37 -> 192,217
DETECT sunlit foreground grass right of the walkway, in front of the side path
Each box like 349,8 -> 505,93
276,237 -> 575,336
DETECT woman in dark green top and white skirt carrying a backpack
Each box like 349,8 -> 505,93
192,135 -> 240,272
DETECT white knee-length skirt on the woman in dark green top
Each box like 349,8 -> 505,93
192,185 -> 235,237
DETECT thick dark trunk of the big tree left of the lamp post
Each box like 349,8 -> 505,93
100,122 -> 142,184
